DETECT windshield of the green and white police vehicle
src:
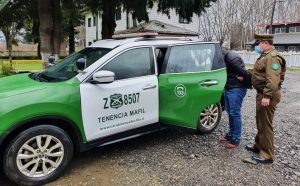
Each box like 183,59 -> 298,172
30,48 -> 111,82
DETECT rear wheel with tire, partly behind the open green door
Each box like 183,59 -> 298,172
197,103 -> 222,134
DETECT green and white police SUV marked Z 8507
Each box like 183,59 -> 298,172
0,34 -> 226,185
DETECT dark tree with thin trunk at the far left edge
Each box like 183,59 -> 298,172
0,0 -> 26,67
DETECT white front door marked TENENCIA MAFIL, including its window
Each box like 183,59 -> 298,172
80,47 -> 158,141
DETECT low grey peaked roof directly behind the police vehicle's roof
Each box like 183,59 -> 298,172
115,20 -> 199,36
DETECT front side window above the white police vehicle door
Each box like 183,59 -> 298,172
101,48 -> 155,80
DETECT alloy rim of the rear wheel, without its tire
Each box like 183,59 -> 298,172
200,104 -> 219,129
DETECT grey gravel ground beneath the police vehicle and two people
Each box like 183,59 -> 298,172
0,72 -> 300,186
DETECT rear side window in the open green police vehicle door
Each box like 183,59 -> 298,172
165,44 -> 215,73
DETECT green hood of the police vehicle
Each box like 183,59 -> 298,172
0,74 -> 46,99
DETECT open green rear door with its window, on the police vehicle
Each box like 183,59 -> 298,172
159,43 -> 226,128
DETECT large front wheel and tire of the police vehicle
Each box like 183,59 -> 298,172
3,125 -> 73,185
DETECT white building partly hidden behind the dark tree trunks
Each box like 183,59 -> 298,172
85,4 -> 199,46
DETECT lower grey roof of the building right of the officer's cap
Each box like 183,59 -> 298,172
247,33 -> 300,45
